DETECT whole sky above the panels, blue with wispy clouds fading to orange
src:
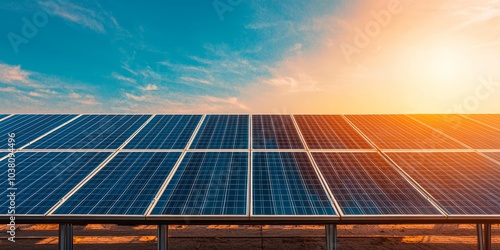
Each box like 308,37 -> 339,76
0,0 -> 500,113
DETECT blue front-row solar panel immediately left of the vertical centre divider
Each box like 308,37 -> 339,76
151,152 -> 248,215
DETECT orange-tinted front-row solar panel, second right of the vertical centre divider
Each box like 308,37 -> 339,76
313,153 -> 440,215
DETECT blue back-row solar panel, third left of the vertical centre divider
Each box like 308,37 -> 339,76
27,115 -> 150,149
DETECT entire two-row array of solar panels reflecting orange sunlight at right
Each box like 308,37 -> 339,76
0,114 -> 500,222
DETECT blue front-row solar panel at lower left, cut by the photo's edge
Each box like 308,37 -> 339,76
0,152 -> 110,215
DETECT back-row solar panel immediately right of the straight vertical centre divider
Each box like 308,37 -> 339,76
252,115 -> 304,149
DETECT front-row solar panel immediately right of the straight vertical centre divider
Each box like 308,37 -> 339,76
252,152 -> 336,216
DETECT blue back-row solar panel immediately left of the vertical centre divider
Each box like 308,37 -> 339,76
191,115 -> 249,149
